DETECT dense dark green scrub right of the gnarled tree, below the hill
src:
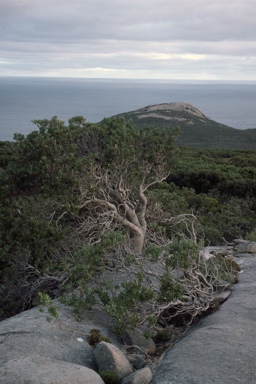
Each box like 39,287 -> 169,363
168,148 -> 256,245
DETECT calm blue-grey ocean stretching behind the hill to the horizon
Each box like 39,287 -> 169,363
0,77 -> 256,141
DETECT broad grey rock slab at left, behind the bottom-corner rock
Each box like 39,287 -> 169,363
0,302 -> 122,369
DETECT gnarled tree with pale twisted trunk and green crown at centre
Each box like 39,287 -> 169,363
76,118 -> 178,253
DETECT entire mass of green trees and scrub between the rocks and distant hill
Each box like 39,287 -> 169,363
0,109 -> 256,332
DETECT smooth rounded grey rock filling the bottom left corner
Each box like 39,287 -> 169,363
0,357 -> 104,384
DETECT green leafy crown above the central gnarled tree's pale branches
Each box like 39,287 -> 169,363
81,118 -> 178,199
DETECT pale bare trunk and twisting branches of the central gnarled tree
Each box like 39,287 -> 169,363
80,164 -> 167,254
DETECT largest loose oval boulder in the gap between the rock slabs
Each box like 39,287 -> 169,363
93,341 -> 132,379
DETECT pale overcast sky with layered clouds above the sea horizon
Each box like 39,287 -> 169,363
0,0 -> 256,81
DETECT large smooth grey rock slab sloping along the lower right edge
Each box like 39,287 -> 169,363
152,255 -> 256,384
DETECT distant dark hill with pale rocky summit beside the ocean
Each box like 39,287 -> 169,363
111,102 -> 256,150
